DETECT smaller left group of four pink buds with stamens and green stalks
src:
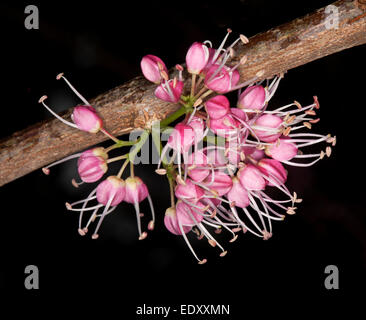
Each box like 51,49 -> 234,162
39,73 -> 155,240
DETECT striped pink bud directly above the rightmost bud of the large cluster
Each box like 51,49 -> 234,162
254,114 -> 283,142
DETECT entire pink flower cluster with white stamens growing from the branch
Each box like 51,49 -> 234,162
39,29 -> 336,264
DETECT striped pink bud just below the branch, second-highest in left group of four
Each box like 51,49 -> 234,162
78,148 -> 108,183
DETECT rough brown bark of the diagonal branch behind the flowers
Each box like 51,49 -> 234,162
0,0 -> 366,186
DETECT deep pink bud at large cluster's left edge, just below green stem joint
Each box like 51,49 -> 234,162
168,122 -> 195,153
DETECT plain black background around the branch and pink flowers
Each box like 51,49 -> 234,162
0,0 -> 366,319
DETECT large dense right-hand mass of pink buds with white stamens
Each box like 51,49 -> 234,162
141,30 -> 336,264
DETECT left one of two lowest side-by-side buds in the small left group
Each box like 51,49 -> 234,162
96,176 -> 126,206
